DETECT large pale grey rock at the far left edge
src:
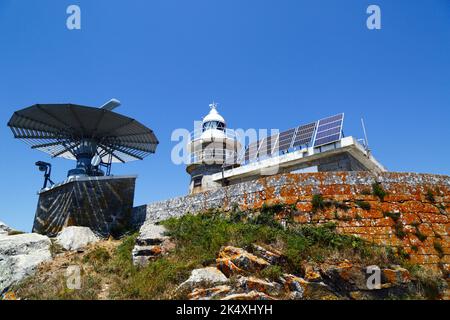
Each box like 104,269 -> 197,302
0,233 -> 52,293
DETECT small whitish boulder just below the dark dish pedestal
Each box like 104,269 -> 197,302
56,226 -> 100,251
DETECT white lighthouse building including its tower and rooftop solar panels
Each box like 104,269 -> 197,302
186,104 -> 386,194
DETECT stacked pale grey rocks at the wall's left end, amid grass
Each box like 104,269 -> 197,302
132,222 -> 175,267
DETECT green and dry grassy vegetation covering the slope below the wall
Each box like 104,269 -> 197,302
13,205 -> 441,299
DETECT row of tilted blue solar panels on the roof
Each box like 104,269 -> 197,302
240,113 -> 344,163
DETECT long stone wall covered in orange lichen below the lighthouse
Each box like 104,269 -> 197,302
134,172 -> 450,271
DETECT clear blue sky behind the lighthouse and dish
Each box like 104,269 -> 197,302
0,0 -> 450,231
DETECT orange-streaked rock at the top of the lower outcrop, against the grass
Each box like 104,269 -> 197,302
216,246 -> 270,276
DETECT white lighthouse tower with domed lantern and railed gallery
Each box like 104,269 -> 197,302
186,102 -> 241,194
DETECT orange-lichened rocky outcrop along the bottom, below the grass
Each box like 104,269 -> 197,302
172,245 -> 428,300
